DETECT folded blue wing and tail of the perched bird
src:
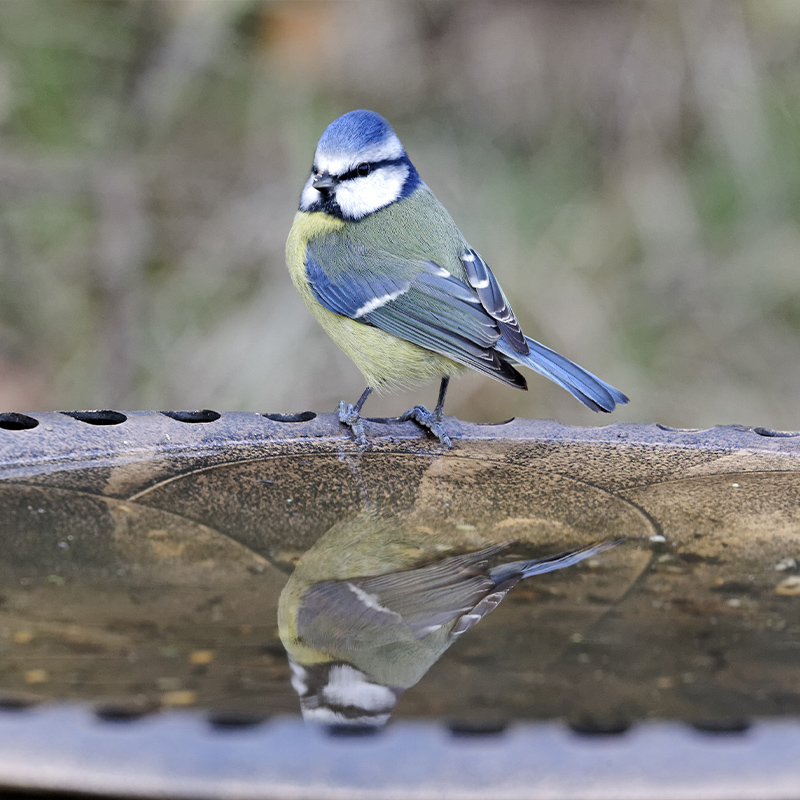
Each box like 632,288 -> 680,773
306,237 -> 628,411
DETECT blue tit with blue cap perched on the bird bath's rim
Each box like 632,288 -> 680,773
286,110 -> 628,447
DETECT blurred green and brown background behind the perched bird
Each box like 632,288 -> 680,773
0,0 -> 800,429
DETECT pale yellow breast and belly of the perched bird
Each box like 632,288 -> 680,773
286,211 -> 465,391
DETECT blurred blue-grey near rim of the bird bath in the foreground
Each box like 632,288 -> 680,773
0,706 -> 800,800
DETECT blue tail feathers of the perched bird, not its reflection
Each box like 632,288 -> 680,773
495,336 -> 628,411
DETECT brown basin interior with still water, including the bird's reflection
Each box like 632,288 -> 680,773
0,415 -> 800,726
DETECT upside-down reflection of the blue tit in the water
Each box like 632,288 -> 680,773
278,511 -> 618,727
